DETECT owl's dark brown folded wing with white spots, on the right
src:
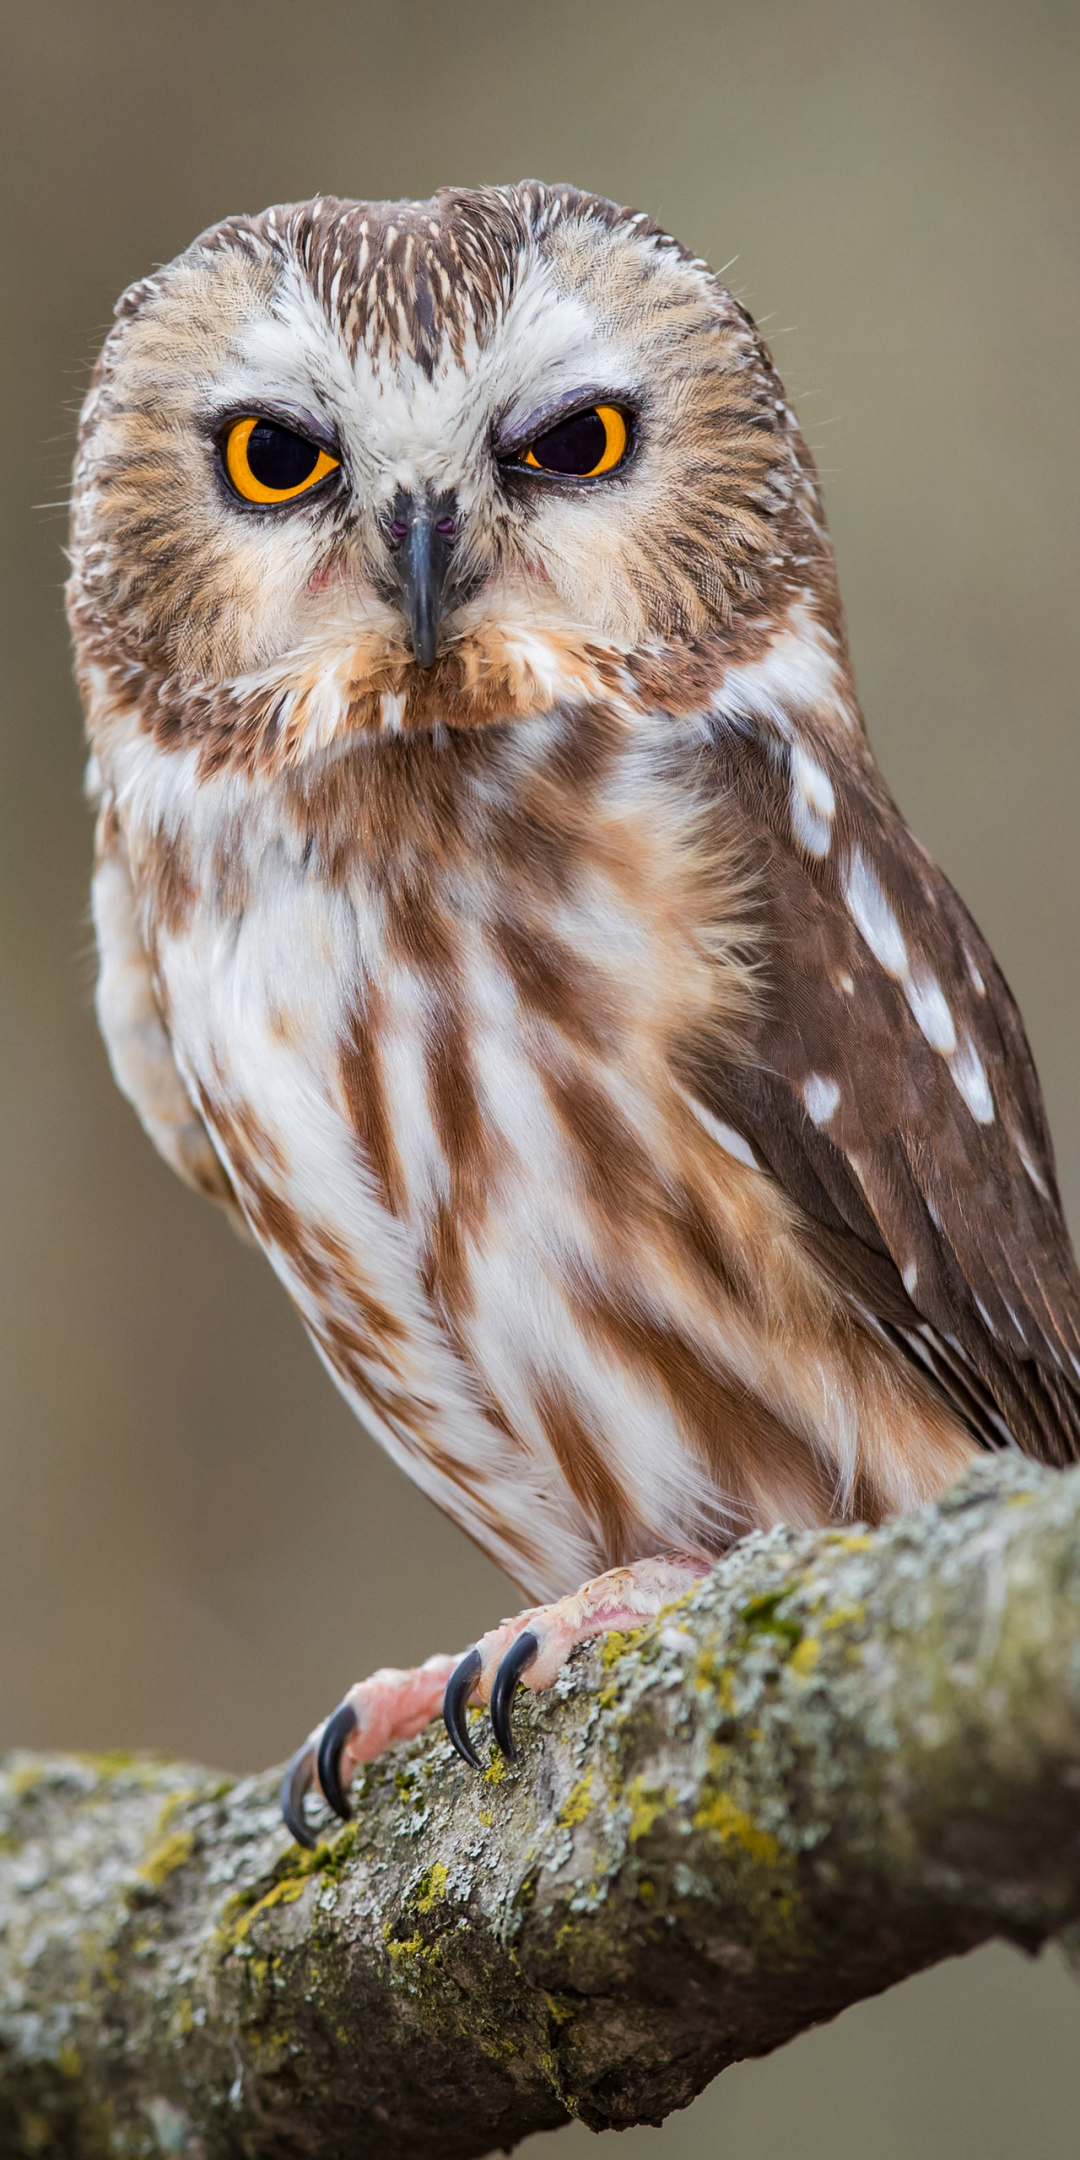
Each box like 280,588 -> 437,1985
687,728 -> 1080,1462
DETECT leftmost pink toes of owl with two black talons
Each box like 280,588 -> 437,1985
281,1657 -> 456,1851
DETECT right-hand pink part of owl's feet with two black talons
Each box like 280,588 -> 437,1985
443,1553 -> 713,1769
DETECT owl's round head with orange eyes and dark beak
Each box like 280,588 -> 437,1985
69,181 -> 827,754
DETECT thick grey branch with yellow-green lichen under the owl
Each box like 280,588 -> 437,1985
0,1458 -> 1080,2160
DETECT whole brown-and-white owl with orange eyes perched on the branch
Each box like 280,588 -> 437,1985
69,181 -> 1080,1845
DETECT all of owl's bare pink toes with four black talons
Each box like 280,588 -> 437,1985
281,1553 -> 708,1851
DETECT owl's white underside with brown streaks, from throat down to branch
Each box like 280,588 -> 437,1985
126,725 -> 868,1594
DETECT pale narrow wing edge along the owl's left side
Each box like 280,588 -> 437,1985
91,801 -> 248,1238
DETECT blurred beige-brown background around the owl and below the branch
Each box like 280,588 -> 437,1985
0,0 -> 1080,2160
